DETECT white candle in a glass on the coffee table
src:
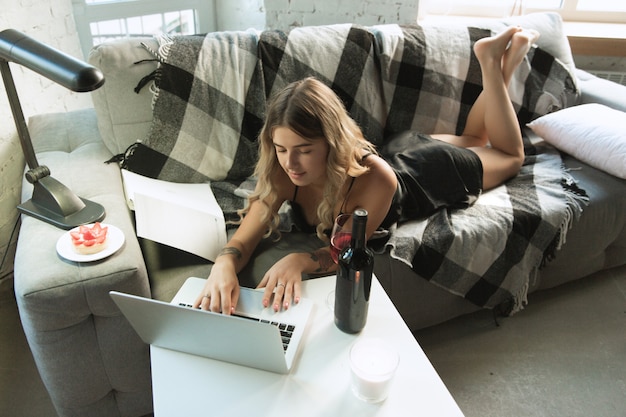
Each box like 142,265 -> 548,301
350,338 -> 400,403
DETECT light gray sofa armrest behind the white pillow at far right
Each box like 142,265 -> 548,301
576,69 -> 626,112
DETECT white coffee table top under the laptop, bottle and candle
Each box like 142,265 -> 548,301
151,276 -> 463,417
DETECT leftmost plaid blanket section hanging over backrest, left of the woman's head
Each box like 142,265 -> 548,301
122,30 -> 265,182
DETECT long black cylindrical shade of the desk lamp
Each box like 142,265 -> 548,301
0,29 -> 104,92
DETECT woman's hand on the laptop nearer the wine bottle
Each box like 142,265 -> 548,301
257,253 -> 311,312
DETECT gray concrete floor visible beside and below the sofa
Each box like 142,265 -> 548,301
0,267 -> 626,417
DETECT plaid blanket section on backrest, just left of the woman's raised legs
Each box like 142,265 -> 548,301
372,25 -> 482,137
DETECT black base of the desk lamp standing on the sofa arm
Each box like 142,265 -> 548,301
17,176 -> 105,230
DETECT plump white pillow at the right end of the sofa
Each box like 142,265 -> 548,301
528,103 -> 626,179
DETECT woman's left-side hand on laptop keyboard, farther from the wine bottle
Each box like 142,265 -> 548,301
193,262 -> 239,314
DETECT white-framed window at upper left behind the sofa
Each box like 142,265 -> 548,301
72,0 -> 215,57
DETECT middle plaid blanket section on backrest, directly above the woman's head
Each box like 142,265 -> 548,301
259,24 -> 387,144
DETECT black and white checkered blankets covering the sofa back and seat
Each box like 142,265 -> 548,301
123,25 -> 582,311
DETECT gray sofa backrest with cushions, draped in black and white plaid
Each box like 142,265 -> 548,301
89,13 -> 578,182
